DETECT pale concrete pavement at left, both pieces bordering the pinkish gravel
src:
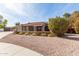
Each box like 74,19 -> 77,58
0,32 -> 43,56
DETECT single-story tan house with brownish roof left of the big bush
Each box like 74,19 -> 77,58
16,22 -> 49,32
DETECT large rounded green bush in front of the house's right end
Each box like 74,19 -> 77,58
48,17 -> 69,36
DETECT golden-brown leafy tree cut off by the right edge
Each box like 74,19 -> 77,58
69,11 -> 79,33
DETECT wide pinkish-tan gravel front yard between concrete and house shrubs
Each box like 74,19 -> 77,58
0,34 -> 79,56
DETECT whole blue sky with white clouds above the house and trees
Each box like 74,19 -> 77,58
0,3 -> 79,26
